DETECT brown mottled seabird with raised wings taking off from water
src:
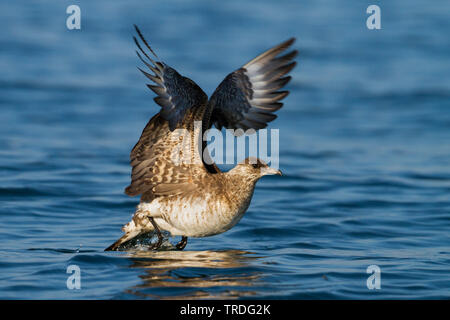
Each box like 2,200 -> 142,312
105,25 -> 298,251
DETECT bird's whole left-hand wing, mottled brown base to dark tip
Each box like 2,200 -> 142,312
125,27 -> 207,196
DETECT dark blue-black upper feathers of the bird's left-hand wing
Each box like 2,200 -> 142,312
133,26 -> 207,131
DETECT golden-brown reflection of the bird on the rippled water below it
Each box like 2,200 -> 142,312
126,250 -> 261,299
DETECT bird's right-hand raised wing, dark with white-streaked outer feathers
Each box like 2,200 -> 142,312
209,38 -> 298,130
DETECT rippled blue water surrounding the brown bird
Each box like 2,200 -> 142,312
0,0 -> 450,299
